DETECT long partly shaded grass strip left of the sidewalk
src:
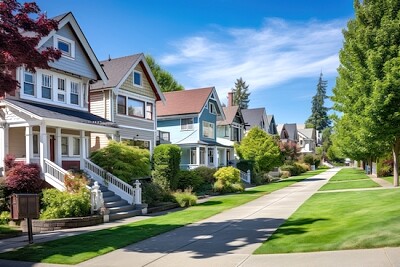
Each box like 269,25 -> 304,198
0,170 -> 325,264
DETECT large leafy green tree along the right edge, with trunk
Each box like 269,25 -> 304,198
333,0 -> 400,186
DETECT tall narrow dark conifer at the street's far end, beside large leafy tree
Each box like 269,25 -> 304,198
306,72 -> 331,131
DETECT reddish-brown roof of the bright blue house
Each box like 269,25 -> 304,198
157,87 -> 214,117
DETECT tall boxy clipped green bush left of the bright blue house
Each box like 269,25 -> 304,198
153,144 -> 181,191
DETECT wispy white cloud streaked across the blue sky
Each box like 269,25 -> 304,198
160,19 -> 346,103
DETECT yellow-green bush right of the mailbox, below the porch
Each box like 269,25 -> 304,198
40,189 -> 90,219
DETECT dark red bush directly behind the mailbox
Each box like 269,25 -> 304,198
6,163 -> 44,193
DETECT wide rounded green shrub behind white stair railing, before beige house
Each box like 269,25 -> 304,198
90,141 -> 151,184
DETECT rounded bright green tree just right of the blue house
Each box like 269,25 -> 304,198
235,127 -> 282,173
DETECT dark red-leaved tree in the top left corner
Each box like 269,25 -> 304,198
0,0 -> 61,95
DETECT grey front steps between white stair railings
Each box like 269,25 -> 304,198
91,182 -> 142,221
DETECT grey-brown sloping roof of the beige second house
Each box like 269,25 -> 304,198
90,54 -> 141,89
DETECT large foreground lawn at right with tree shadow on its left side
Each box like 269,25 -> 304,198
255,189 -> 400,254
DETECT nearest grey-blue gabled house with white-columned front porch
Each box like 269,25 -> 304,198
0,13 -> 118,178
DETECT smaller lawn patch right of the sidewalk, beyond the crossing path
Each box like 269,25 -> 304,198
319,168 -> 380,191
